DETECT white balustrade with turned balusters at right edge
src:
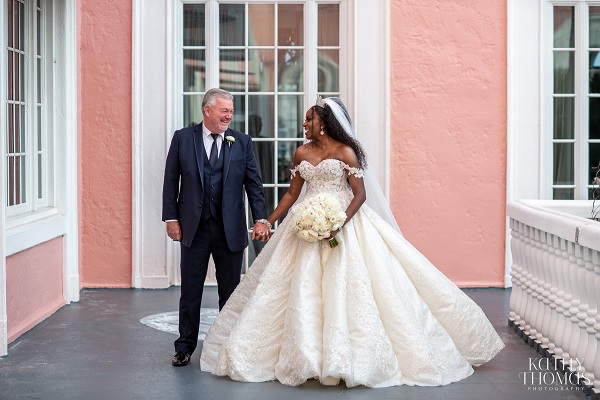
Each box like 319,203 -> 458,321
507,200 -> 600,398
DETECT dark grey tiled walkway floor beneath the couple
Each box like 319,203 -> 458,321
0,288 -> 585,400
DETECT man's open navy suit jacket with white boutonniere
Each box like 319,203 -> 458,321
162,124 -> 267,251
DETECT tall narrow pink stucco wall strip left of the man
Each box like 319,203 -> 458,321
78,0 -> 132,287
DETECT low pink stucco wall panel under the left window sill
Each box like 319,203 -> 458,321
6,237 -> 66,343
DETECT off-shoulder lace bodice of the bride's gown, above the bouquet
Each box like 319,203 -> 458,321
291,158 -> 363,197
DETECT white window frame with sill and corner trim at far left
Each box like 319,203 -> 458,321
0,0 -> 79,355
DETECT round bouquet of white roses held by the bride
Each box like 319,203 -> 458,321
292,193 -> 346,247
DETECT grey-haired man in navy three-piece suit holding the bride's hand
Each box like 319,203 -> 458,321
162,89 -> 271,366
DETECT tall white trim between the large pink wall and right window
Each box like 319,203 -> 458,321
504,0 -> 544,287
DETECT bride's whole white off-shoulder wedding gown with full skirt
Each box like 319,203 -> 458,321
200,159 -> 504,387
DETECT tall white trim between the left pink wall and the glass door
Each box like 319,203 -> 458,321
132,0 -> 175,288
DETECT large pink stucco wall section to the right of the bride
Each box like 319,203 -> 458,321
390,0 -> 507,287
